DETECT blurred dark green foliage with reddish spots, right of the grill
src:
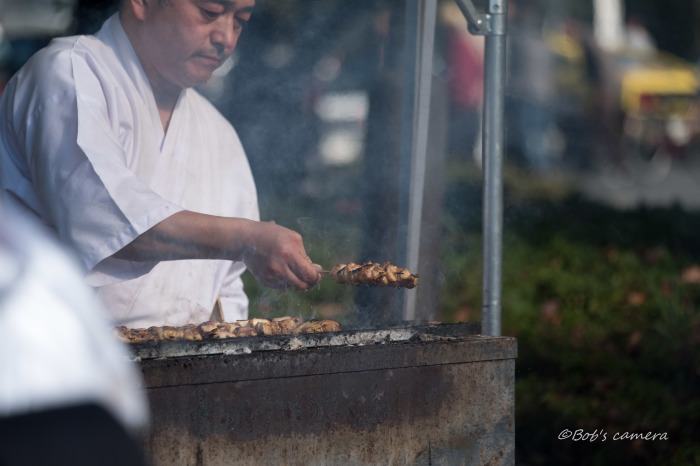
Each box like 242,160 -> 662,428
441,172 -> 700,465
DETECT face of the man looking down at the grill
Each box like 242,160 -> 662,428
139,0 -> 255,88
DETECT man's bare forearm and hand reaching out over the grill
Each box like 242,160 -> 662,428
113,211 -> 321,290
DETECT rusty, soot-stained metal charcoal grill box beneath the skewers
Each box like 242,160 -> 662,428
133,323 -> 517,466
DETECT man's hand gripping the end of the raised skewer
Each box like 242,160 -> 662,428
242,222 -> 321,290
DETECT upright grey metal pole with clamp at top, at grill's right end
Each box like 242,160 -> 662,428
481,0 -> 508,335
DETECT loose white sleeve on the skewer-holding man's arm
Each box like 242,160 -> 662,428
14,45 -> 182,286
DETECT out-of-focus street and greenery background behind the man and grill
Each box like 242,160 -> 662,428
0,0 -> 700,465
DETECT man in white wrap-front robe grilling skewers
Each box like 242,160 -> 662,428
0,0 -> 321,327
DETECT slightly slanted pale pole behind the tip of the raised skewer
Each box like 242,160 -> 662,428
398,0 -> 437,321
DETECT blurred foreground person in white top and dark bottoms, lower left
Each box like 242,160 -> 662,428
0,204 -> 147,466
